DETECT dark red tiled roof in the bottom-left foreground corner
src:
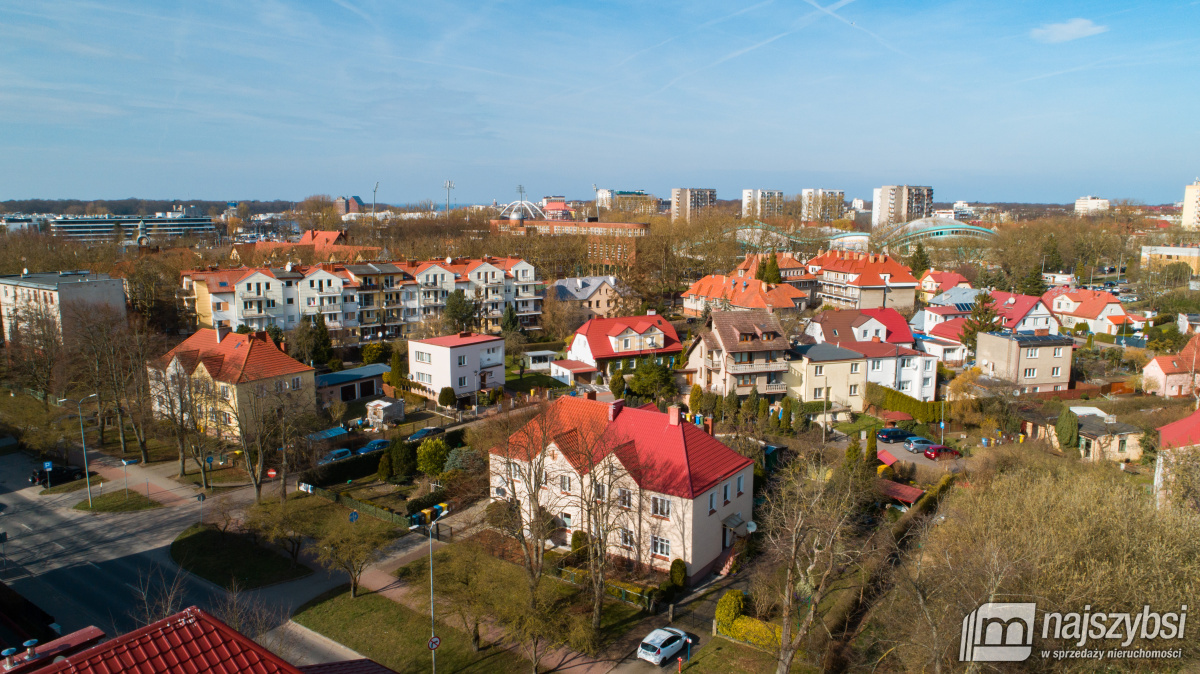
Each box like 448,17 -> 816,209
38,606 -> 301,674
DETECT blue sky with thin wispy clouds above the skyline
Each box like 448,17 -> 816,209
0,0 -> 1200,203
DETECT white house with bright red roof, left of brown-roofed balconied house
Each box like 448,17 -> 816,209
561,312 -> 683,381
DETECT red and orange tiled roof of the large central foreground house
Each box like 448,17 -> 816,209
491,396 -> 754,499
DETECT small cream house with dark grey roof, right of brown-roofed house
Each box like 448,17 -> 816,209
784,344 -> 866,413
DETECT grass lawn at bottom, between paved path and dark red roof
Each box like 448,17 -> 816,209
292,585 -> 529,673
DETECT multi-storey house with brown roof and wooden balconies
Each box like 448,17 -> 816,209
686,311 -> 791,403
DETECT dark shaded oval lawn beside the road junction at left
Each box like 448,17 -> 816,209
170,524 -> 312,590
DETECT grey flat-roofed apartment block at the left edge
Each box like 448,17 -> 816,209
0,270 -> 125,339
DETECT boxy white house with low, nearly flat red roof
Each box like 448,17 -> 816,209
408,332 -> 504,401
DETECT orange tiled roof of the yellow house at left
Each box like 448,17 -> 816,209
158,329 -> 312,384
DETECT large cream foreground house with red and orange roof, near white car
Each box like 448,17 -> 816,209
488,396 -> 754,579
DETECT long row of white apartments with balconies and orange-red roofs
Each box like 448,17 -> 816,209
181,257 -> 542,341
